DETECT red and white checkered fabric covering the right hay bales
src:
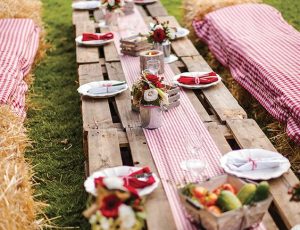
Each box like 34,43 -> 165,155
193,4 -> 300,143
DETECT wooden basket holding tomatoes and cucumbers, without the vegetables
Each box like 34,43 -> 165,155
179,175 -> 272,230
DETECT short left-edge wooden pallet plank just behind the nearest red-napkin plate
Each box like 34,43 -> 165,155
88,128 -> 122,174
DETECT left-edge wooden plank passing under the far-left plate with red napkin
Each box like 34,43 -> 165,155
76,21 -> 99,64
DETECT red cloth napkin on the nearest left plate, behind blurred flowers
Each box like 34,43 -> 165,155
124,167 -> 155,189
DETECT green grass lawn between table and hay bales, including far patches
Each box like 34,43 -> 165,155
26,0 -> 300,229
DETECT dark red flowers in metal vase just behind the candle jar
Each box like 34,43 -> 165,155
148,17 -> 175,57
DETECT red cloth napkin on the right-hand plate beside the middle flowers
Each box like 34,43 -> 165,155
177,72 -> 218,85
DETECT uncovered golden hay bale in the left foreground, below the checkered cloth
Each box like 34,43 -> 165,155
0,106 -> 45,230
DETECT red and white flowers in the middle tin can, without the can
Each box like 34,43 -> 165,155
132,71 -> 169,107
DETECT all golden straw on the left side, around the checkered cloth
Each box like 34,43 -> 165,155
0,0 -> 47,230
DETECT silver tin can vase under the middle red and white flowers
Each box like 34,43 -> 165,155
140,105 -> 163,129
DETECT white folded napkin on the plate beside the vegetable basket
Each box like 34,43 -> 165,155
226,155 -> 286,172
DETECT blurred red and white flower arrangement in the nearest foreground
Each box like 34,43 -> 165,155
83,177 -> 146,230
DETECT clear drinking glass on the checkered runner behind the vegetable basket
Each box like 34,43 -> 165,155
180,134 -> 207,180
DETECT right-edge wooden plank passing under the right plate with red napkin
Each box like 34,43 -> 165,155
182,56 -> 247,122
